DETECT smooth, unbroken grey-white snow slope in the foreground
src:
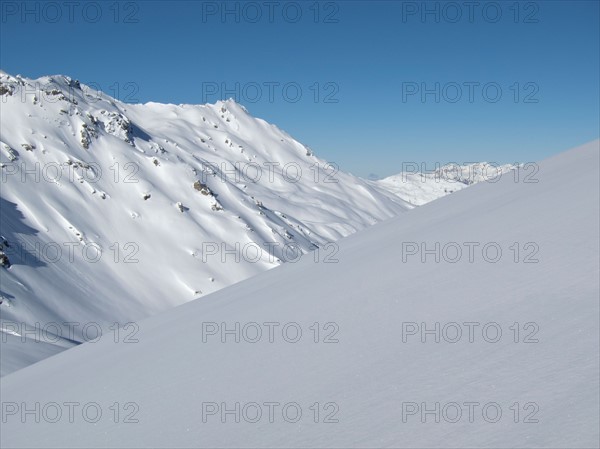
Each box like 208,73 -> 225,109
0,141 -> 600,448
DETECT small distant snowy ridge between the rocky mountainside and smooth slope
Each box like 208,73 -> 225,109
372,162 -> 524,206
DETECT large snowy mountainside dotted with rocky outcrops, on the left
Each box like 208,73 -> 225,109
0,72 -> 410,374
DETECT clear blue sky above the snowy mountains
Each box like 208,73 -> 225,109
0,0 -> 600,176
